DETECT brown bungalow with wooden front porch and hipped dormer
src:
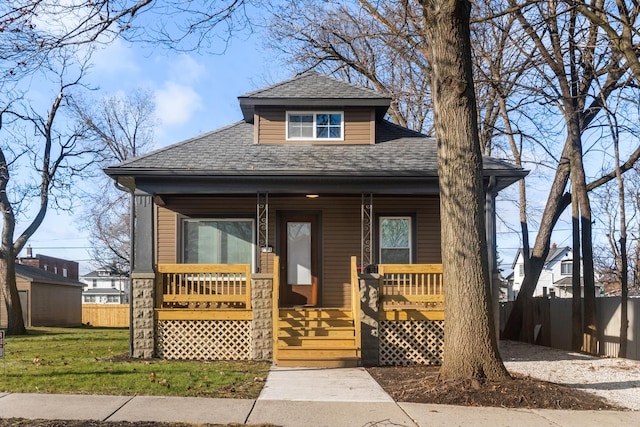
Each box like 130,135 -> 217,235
105,73 -> 526,366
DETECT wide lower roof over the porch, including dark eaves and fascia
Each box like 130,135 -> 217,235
105,120 -> 527,194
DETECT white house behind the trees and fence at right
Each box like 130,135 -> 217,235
508,244 -> 602,301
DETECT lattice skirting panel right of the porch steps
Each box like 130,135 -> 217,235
379,320 -> 444,365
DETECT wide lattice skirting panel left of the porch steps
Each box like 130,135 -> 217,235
156,320 -> 251,360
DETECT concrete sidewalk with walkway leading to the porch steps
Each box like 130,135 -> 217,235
0,368 -> 639,427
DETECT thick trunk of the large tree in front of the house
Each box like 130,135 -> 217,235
420,0 -> 509,380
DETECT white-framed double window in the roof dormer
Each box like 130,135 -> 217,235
287,111 -> 344,141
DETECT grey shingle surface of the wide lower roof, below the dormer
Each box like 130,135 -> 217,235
107,121 -> 514,177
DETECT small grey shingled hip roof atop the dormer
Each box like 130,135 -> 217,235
239,72 -> 389,99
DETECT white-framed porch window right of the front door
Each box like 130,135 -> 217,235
380,217 -> 412,264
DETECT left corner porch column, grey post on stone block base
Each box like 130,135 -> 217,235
130,193 -> 156,359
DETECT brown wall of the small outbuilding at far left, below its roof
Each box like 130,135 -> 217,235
30,283 -> 82,326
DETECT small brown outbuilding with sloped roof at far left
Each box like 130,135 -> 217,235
0,263 -> 82,327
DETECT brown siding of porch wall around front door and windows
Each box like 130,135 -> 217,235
157,196 -> 441,307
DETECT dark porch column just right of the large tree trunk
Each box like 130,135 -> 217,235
484,176 -> 500,339
